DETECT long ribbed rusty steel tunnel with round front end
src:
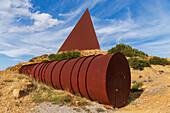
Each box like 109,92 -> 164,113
19,53 -> 131,108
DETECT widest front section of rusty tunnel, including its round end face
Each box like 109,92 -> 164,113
86,53 -> 130,107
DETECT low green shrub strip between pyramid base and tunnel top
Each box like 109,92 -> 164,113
48,51 -> 81,61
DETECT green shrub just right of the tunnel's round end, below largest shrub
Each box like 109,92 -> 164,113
128,57 -> 150,70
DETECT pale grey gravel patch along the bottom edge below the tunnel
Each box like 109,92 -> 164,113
29,102 -> 115,113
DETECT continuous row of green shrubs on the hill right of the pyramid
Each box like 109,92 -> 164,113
108,44 -> 170,70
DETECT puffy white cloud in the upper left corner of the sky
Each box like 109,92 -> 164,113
0,0 -> 63,33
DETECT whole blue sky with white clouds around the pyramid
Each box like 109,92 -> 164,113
0,0 -> 170,70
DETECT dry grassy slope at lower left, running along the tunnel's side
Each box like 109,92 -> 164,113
0,71 -> 91,113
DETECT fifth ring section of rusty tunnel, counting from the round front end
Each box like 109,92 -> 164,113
52,60 -> 69,89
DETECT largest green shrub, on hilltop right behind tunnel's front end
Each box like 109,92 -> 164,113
108,44 -> 148,57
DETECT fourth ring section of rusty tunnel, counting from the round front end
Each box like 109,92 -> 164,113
60,58 -> 79,92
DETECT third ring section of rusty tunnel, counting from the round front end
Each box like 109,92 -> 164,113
71,57 -> 87,94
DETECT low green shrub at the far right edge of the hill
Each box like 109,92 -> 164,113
149,57 -> 170,66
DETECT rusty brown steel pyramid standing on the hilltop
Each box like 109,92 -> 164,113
58,9 -> 100,52
